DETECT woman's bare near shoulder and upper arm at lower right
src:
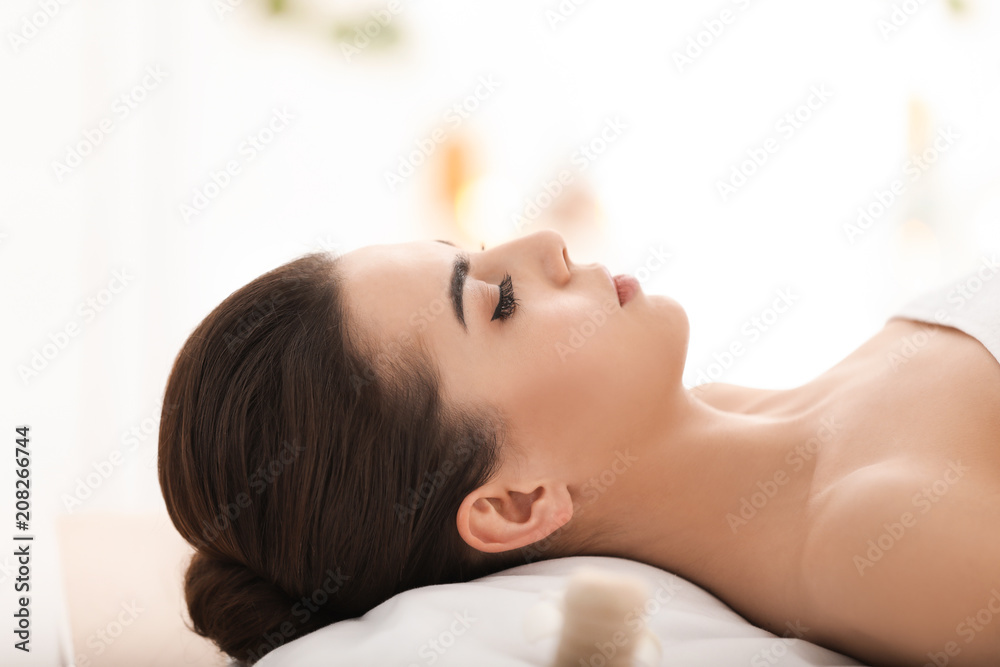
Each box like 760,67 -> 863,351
801,459 -> 1000,667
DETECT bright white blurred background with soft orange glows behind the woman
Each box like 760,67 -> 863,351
0,0 -> 1000,665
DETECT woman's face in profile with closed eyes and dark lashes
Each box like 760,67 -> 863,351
341,230 -> 688,488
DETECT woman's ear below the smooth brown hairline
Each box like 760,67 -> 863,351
457,479 -> 573,553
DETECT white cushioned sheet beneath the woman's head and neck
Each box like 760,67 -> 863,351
257,556 -> 861,667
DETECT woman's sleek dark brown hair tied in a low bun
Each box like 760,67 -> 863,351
158,253 -> 556,664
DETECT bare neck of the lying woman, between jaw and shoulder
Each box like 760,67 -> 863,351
588,388 -> 836,591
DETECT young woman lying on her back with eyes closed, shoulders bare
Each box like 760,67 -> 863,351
159,231 -> 1000,665
